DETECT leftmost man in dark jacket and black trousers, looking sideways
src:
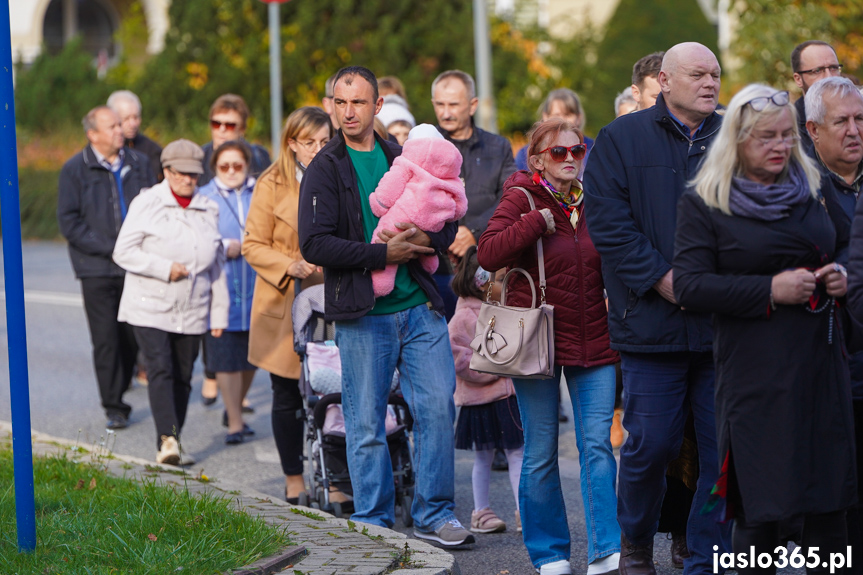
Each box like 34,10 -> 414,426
57,106 -> 156,429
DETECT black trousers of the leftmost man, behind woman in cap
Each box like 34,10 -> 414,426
81,277 -> 138,417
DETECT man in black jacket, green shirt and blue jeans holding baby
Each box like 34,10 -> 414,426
298,66 -> 474,546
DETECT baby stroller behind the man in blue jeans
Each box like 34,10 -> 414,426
292,285 -> 414,527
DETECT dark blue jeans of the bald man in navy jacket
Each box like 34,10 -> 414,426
617,352 -> 731,575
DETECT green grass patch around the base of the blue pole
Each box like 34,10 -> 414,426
0,445 -> 289,575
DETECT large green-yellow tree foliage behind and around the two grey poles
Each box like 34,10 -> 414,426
134,0 -> 544,139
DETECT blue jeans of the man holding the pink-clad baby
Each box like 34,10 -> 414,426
336,304 -> 455,531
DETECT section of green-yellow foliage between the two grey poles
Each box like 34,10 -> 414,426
282,0 -> 473,126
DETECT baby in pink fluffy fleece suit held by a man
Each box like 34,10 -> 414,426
369,124 -> 467,297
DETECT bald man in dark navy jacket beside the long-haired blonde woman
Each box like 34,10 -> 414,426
584,43 -> 730,575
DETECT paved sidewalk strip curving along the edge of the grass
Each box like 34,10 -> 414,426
0,421 -> 461,575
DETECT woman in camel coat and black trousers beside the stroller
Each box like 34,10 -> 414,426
243,107 -> 333,503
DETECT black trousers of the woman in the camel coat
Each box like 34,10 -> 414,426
270,373 -> 305,475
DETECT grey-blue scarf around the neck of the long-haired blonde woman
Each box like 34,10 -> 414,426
728,160 -> 809,222
